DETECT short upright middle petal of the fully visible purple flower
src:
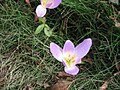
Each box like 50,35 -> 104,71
63,40 -> 74,53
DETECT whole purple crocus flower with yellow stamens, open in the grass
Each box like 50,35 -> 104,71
50,38 -> 92,75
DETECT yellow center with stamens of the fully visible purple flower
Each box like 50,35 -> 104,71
64,54 -> 76,66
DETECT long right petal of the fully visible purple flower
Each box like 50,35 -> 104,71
75,38 -> 92,58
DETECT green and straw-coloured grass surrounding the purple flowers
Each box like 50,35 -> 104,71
0,0 -> 120,90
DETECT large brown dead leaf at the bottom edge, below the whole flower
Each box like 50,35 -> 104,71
52,80 -> 72,90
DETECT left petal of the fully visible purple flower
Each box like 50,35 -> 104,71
50,43 -> 63,62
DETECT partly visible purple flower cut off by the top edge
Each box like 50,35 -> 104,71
36,0 -> 62,17
